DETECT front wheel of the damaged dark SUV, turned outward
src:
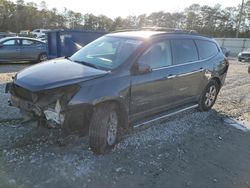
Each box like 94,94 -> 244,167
89,103 -> 121,154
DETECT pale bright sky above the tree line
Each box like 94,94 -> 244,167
12,0 -> 241,18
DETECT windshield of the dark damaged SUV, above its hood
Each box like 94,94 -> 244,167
70,36 -> 142,70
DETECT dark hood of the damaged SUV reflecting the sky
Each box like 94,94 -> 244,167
14,59 -> 108,92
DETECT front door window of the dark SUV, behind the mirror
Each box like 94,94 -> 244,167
138,41 -> 172,69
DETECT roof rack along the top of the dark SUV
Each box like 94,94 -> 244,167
114,27 -> 198,34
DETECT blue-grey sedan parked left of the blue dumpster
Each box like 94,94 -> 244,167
0,37 -> 48,62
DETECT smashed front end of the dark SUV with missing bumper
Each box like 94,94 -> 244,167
6,82 -> 80,128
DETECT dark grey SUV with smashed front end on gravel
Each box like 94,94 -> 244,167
6,30 -> 229,154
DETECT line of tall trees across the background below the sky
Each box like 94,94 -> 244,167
0,0 -> 250,37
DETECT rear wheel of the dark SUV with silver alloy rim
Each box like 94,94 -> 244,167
198,80 -> 220,112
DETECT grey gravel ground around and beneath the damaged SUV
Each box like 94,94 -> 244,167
0,61 -> 250,188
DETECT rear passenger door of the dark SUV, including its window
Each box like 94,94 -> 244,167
172,39 -> 204,106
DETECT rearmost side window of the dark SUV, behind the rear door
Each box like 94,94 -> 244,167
195,40 -> 218,60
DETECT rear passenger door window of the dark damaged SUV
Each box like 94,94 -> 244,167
172,39 -> 198,64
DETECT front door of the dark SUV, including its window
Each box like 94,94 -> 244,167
130,40 -> 174,121
